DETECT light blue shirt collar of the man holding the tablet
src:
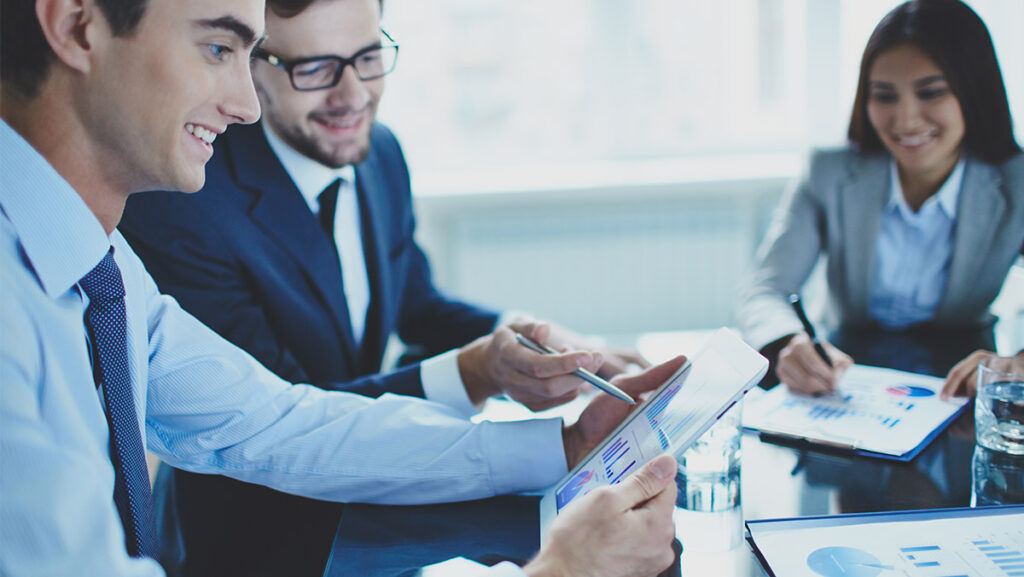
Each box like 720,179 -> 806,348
0,120 -> 111,298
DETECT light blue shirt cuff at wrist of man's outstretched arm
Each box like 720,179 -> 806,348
479,419 -> 568,495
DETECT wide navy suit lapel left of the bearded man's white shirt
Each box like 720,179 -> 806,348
224,124 -> 355,366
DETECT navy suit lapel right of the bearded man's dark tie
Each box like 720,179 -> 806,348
355,153 -> 394,371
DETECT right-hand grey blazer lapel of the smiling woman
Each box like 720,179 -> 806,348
935,158 -> 1007,319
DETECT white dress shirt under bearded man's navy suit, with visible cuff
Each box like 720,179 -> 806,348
261,122 -> 476,407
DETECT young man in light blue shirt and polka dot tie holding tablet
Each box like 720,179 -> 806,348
0,0 -> 681,577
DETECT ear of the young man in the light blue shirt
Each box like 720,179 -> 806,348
36,0 -> 110,72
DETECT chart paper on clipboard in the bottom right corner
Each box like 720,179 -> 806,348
752,510 -> 1024,577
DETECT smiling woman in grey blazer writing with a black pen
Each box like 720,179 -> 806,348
736,0 -> 1024,395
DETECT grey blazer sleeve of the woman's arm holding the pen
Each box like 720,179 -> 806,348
736,152 -> 824,349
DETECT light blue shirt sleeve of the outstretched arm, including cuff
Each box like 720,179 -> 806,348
136,272 -> 566,504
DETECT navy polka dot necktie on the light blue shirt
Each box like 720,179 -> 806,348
79,248 -> 157,558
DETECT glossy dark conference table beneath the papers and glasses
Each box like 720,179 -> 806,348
325,329 -> 1024,577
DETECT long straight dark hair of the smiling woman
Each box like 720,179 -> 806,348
849,0 -> 1021,165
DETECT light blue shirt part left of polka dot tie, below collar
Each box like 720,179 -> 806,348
0,272 -> 164,577
